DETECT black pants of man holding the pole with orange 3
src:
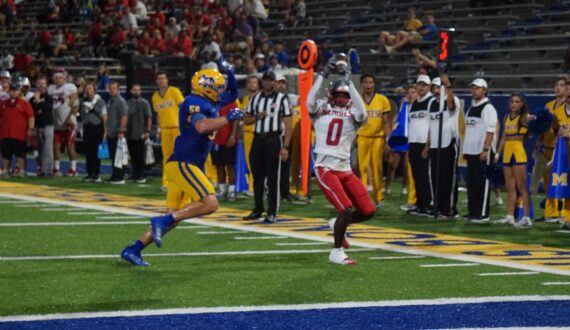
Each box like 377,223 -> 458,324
429,140 -> 457,215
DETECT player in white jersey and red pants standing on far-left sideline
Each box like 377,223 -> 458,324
48,68 -> 77,176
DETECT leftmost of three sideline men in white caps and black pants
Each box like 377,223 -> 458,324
408,75 -> 433,216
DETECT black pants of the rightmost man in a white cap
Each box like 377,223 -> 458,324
465,152 -> 495,217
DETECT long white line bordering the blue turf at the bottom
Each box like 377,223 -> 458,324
0,296 -> 570,323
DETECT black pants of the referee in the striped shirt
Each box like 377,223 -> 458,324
249,134 -> 281,216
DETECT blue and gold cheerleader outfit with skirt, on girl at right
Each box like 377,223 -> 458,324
503,114 -> 528,166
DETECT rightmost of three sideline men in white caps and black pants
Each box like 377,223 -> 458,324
463,78 -> 497,222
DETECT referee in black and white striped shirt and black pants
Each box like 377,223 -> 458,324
244,71 -> 292,222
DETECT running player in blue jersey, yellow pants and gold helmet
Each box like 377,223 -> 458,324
121,66 -> 243,266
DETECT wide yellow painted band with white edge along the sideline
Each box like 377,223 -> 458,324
0,182 -> 570,276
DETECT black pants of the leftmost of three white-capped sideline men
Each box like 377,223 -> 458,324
409,143 -> 431,210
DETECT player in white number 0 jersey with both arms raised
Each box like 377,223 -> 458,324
307,70 -> 375,265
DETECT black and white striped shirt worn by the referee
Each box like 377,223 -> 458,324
245,92 -> 291,134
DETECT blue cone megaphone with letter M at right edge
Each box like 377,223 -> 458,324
547,139 -> 570,199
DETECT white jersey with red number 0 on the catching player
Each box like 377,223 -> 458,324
313,99 -> 361,171
